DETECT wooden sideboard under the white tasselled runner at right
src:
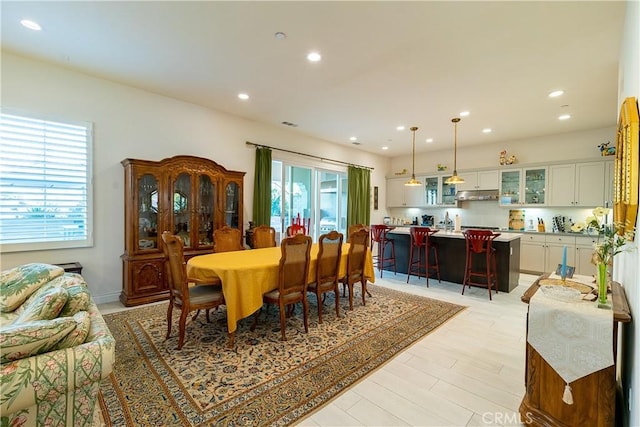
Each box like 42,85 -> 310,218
520,275 -> 631,427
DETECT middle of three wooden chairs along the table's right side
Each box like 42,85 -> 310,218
307,230 -> 344,323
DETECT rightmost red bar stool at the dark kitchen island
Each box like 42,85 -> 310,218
462,230 -> 500,299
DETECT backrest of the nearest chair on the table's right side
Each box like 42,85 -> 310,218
278,234 -> 312,300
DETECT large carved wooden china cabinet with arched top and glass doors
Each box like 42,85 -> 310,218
120,156 -> 245,306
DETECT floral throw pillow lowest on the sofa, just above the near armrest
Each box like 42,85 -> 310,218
0,317 -> 77,363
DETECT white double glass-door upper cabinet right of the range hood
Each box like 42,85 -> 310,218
499,167 -> 547,206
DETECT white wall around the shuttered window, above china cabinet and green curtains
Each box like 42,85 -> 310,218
0,52 -> 389,303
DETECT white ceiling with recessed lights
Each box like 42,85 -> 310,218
1,0 -> 626,157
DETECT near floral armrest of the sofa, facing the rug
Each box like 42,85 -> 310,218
0,300 -> 115,414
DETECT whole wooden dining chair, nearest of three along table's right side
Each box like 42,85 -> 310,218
251,234 -> 311,341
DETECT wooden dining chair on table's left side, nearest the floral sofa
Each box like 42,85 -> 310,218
162,231 -> 224,350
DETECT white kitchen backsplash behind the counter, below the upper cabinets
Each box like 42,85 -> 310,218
388,201 -> 611,233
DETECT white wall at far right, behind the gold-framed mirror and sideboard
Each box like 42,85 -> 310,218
613,1 -> 640,426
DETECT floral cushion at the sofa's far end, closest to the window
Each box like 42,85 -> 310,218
0,263 -> 64,312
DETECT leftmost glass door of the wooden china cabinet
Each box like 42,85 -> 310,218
136,174 -> 159,250
